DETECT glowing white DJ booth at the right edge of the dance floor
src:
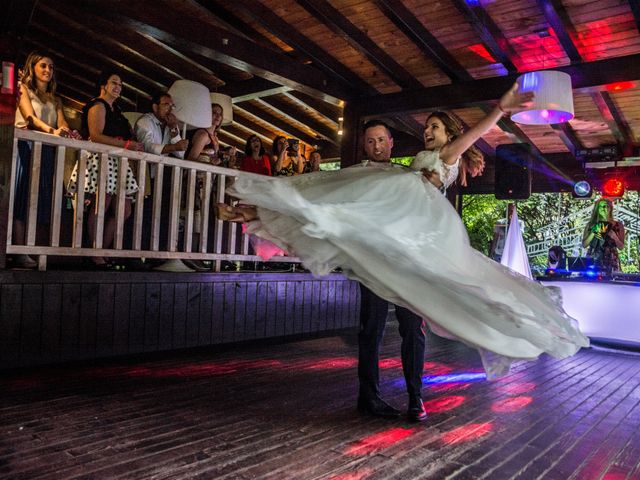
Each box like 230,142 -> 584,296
538,269 -> 640,348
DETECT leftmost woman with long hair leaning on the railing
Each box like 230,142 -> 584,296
12,51 -> 79,268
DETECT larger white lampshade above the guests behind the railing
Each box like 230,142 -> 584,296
169,80 -> 211,128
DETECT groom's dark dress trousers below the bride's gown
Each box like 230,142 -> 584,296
358,284 -> 425,398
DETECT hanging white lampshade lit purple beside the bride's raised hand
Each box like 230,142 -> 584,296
511,70 -> 574,125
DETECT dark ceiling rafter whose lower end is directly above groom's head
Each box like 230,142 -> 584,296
229,0 -> 375,93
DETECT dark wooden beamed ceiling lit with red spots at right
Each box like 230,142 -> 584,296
3,0 -> 640,190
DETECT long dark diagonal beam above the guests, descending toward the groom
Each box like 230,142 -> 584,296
88,2 -> 354,103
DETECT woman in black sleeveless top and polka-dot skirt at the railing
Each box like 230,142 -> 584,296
68,71 -> 144,268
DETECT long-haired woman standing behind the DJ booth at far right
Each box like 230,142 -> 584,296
582,198 -> 625,273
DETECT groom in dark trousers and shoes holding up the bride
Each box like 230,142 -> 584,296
358,120 -> 427,422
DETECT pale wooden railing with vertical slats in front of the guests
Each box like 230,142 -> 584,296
6,129 -> 298,271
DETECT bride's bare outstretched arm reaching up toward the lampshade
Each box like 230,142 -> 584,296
440,83 -> 533,165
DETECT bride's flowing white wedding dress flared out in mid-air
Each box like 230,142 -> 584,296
229,155 -> 589,378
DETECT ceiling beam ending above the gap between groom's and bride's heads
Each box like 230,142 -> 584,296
296,0 -> 423,89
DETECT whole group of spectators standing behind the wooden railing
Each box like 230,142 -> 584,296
12,51 -> 320,268
